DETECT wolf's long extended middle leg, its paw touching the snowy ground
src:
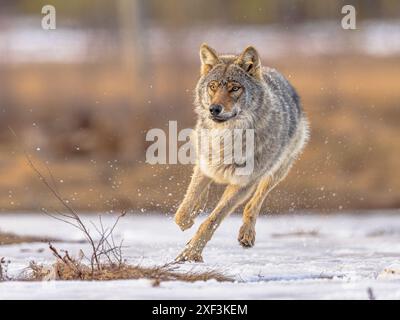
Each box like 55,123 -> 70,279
175,185 -> 254,262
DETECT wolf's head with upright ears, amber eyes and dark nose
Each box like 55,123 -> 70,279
196,44 -> 263,123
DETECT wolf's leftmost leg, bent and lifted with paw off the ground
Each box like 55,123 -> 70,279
175,166 -> 211,231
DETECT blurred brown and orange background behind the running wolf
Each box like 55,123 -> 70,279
0,0 -> 400,213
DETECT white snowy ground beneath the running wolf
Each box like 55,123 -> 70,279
0,211 -> 400,299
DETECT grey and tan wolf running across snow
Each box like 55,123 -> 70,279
175,44 -> 309,262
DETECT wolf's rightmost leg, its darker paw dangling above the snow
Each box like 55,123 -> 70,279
238,176 -> 274,248
